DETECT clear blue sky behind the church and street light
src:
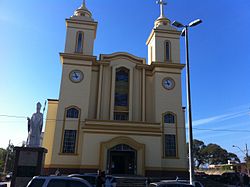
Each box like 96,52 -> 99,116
0,0 -> 250,161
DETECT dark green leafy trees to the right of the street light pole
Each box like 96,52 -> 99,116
189,139 -> 240,168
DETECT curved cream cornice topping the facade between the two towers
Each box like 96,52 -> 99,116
100,52 -> 146,64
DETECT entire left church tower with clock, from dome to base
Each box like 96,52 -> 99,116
47,1 -> 97,159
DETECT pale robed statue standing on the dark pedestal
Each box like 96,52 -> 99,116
26,102 -> 43,147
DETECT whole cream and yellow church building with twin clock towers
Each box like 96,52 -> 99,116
43,3 -> 188,176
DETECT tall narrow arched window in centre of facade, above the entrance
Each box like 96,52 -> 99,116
114,67 -> 129,120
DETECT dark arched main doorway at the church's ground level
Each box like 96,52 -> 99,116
107,144 -> 137,175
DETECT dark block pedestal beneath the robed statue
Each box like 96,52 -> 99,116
11,147 -> 47,187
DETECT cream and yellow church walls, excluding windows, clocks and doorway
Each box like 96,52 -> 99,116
43,6 -> 187,175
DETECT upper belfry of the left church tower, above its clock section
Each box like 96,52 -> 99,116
64,1 -> 97,56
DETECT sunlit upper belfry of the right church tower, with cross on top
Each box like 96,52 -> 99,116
146,0 -> 180,64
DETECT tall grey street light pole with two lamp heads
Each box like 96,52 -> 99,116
172,19 -> 202,184
